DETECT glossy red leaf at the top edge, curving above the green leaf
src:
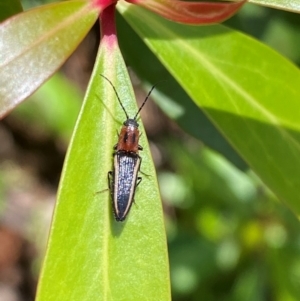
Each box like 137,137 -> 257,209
127,0 -> 246,24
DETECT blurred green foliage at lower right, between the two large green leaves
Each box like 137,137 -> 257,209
163,138 -> 300,301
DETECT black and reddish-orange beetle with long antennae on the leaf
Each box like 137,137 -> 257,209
100,74 -> 155,221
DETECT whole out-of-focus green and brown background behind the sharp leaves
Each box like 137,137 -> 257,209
0,0 -> 300,301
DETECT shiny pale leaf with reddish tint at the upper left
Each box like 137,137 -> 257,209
0,0 -> 99,117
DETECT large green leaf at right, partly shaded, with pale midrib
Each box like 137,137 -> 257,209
118,3 -> 300,213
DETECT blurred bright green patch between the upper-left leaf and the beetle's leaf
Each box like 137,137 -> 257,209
13,73 -> 83,142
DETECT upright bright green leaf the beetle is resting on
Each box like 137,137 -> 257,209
37,19 -> 170,301
